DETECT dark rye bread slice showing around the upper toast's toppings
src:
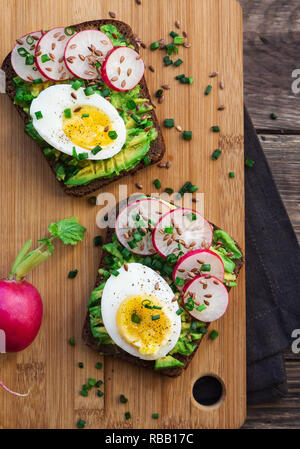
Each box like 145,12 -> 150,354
1,19 -> 166,197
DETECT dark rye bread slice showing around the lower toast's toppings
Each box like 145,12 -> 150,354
82,198 -> 244,377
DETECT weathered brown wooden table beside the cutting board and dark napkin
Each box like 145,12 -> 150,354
239,0 -> 300,428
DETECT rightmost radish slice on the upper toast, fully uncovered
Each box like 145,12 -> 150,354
101,47 -> 145,91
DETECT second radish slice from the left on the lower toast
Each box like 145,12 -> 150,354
152,208 -> 213,257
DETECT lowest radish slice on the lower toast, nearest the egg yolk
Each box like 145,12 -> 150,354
183,275 -> 229,322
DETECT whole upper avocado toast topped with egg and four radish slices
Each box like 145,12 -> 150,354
2,20 -> 165,197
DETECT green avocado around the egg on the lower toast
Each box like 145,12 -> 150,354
88,226 -> 242,370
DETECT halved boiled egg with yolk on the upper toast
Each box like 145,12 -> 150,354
30,84 -> 126,159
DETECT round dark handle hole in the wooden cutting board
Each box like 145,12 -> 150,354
192,374 -> 225,408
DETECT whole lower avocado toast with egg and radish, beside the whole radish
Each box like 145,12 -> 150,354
82,197 -> 244,377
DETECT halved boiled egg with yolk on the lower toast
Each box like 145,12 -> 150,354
101,263 -> 181,360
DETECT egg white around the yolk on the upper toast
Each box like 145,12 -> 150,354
30,84 -> 126,160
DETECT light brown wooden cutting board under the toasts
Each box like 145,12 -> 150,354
0,0 -> 246,428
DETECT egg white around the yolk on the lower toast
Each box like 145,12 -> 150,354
101,263 -> 181,360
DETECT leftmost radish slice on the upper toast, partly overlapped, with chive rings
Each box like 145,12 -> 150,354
11,31 -> 47,83
